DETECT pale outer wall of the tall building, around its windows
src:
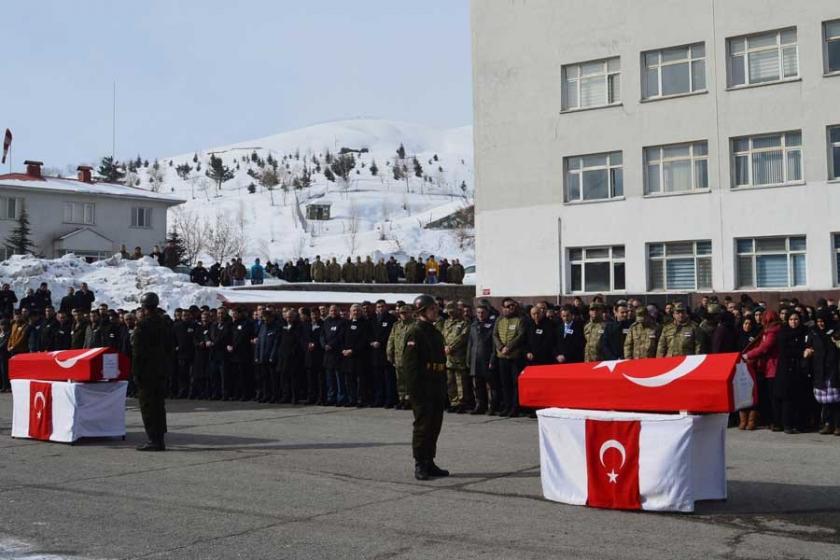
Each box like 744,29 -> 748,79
472,0 -> 840,296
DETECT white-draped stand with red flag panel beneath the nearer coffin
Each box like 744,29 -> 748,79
537,408 -> 728,511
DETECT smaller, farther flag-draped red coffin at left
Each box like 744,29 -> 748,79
9,348 -> 131,382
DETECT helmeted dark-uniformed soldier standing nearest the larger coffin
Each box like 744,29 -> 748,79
402,295 -> 449,480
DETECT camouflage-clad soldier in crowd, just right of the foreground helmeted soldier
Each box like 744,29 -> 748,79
443,303 -> 475,414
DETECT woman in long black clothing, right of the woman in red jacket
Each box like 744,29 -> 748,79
773,310 -> 808,434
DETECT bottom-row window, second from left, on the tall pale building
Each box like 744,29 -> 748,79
648,241 -> 712,290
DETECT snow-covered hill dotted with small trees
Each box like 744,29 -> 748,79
128,120 -> 474,263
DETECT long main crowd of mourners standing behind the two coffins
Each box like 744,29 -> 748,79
0,284 -> 840,435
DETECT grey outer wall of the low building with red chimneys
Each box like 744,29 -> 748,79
0,186 -> 174,258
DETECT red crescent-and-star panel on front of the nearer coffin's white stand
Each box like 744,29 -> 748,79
586,419 -> 642,509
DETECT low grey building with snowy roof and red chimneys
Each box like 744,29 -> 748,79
0,161 -> 184,260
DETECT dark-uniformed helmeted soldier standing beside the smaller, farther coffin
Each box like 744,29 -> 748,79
131,292 -> 171,451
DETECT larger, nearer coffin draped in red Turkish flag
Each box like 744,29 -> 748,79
519,354 -> 757,413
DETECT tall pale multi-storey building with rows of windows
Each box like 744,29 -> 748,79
472,0 -> 840,298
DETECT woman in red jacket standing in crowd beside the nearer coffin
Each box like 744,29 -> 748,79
744,310 -> 782,431
